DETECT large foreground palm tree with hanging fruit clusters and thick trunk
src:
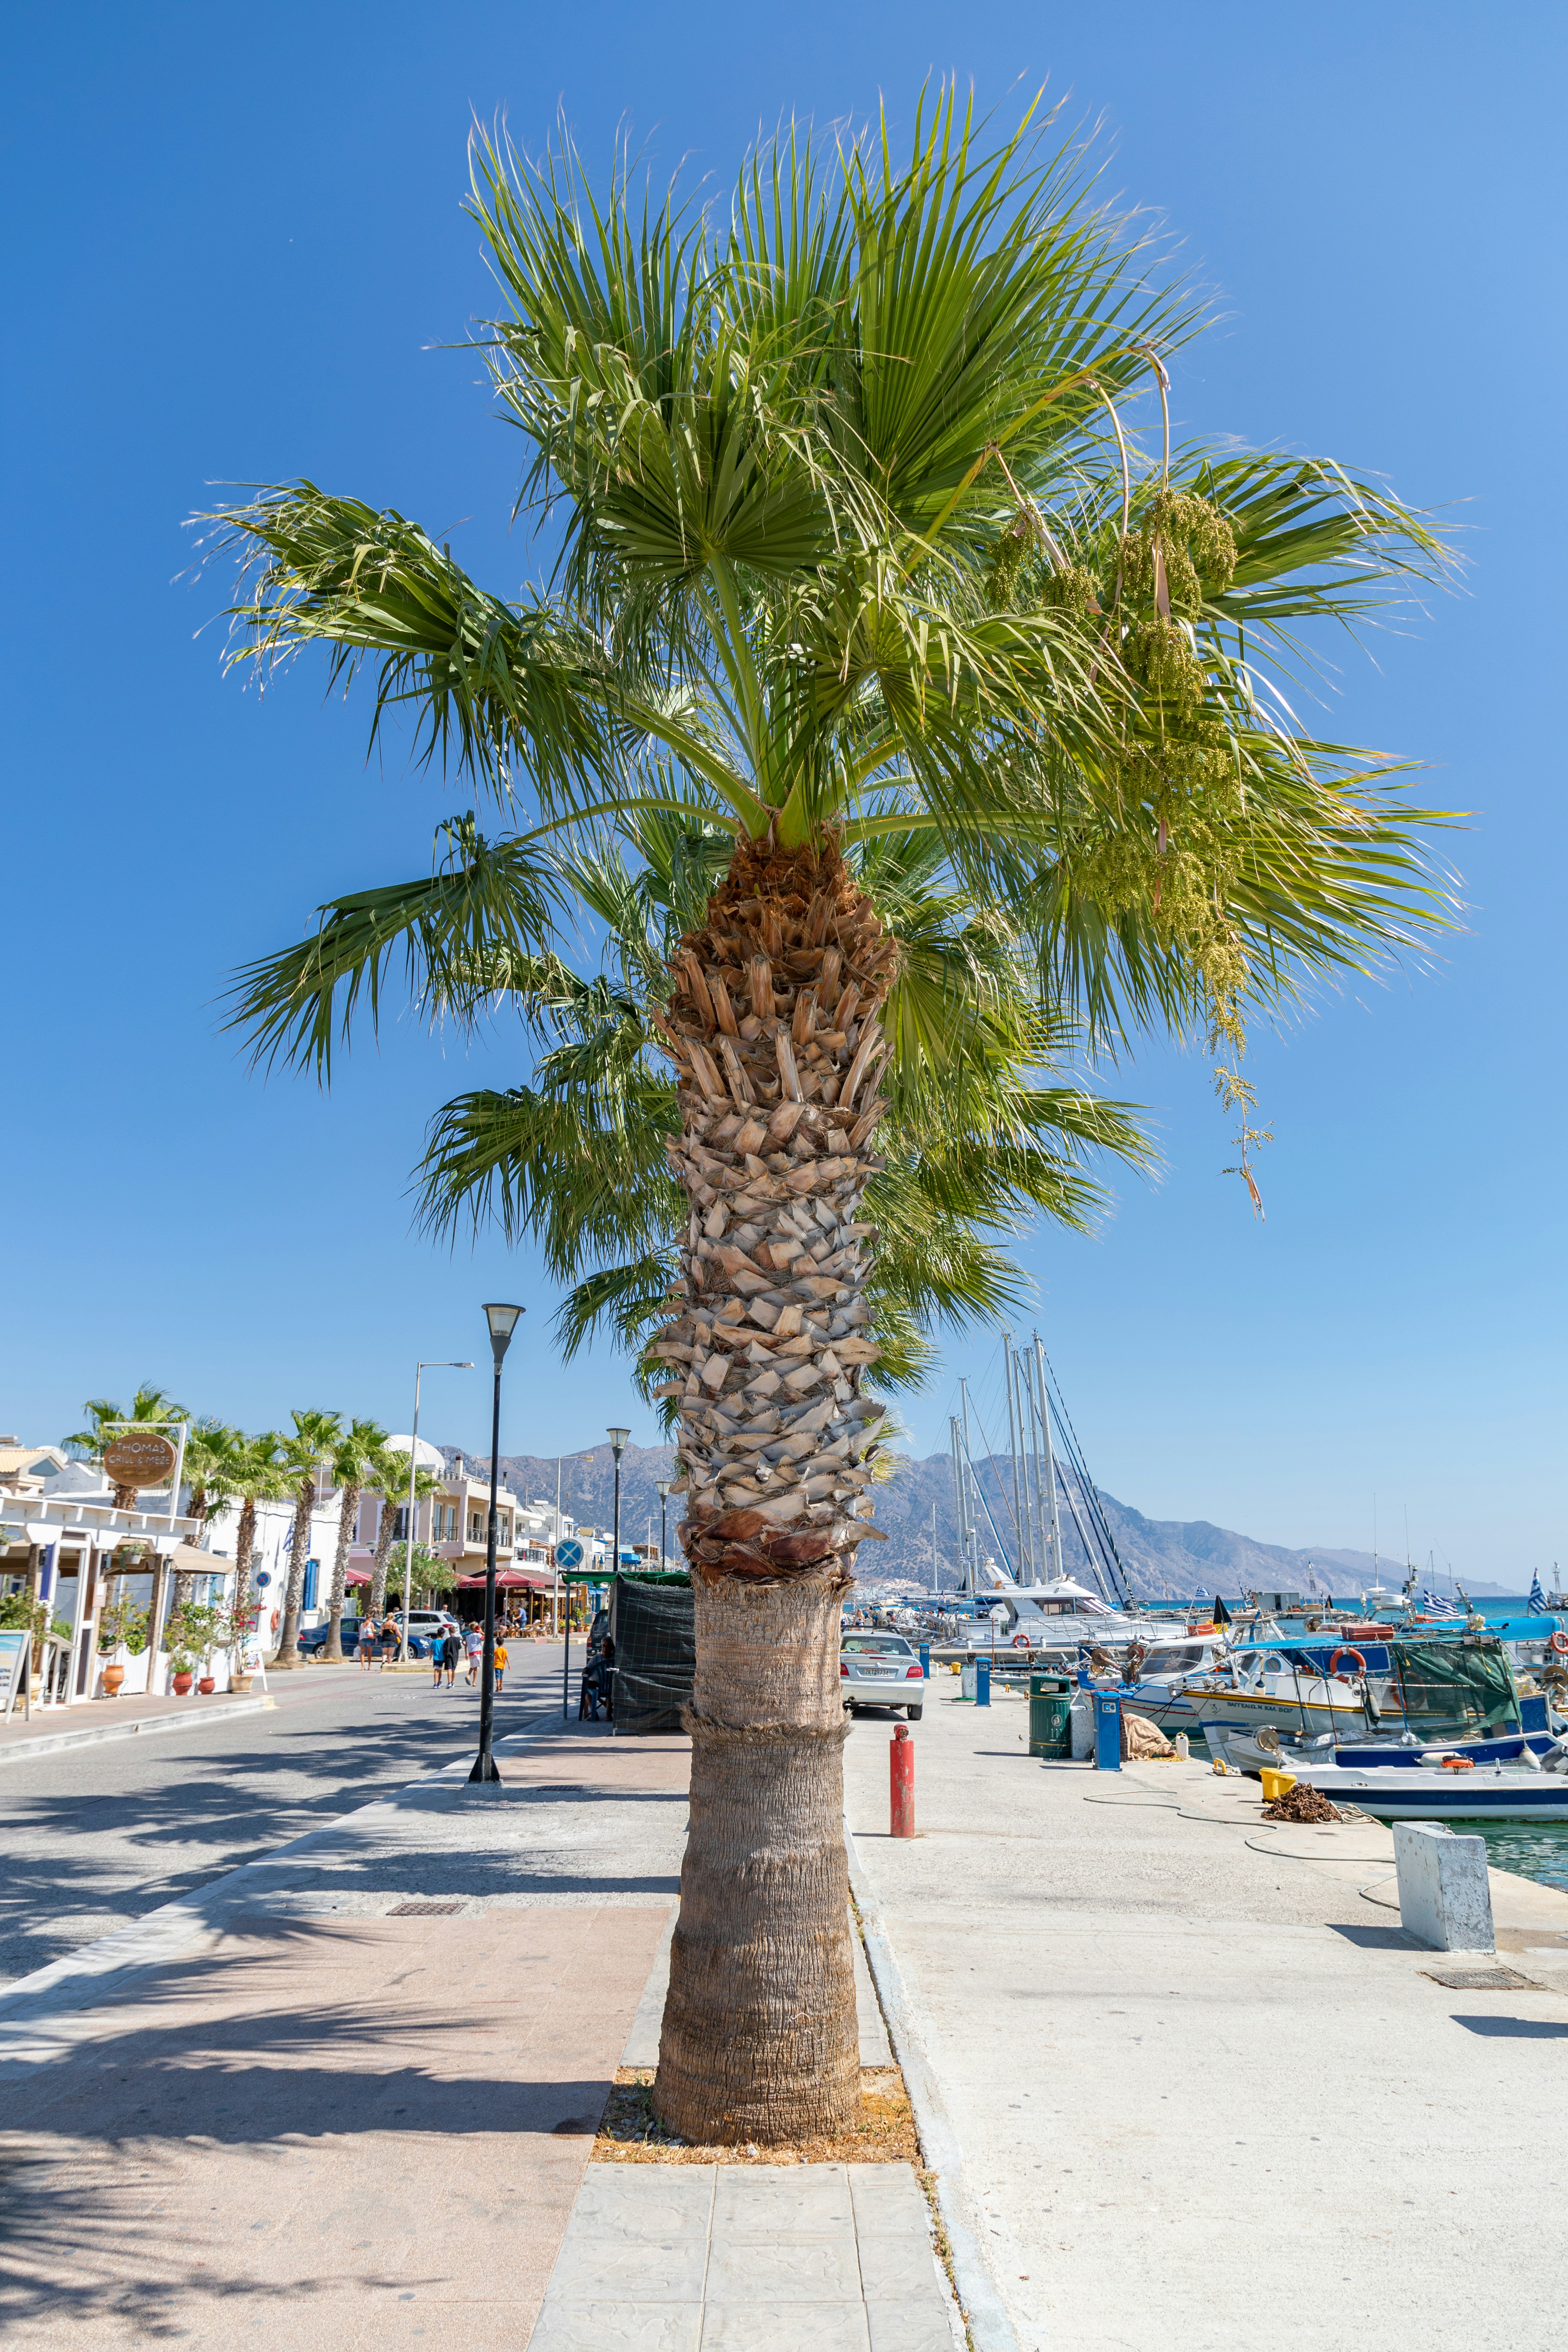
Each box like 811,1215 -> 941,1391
208,94 -> 1446,2143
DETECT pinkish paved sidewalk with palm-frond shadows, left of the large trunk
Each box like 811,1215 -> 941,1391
0,1724 -> 686,2352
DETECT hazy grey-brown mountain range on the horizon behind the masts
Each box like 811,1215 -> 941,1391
442,1444 -> 1509,1600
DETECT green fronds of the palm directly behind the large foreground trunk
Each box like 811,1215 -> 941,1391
421,814 -> 1152,1390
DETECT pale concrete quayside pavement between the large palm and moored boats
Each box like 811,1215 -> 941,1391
846,1698 -> 1568,2352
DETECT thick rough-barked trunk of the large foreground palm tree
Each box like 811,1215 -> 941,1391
653,842 -> 896,2145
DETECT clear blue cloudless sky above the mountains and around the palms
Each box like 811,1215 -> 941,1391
0,0 -> 1568,1581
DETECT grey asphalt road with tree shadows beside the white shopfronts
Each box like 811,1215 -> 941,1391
0,1642 -> 583,1985
